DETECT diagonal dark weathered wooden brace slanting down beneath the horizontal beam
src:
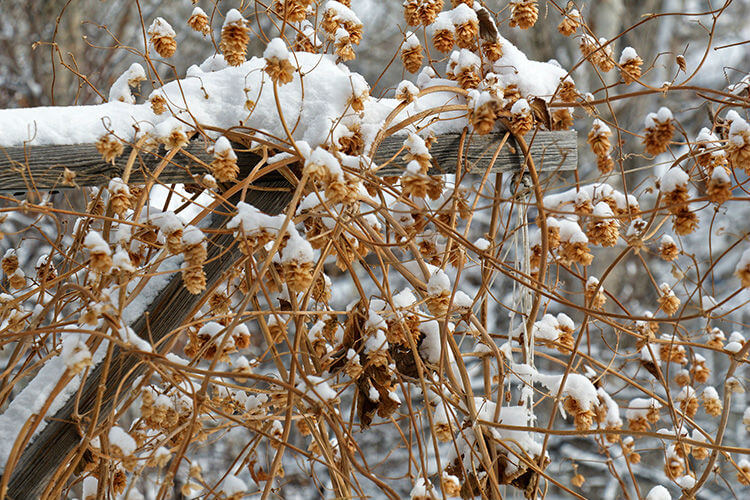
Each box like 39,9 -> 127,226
7,181 -> 292,500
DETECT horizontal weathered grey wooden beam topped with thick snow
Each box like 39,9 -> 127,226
0,131 -> 578,191
